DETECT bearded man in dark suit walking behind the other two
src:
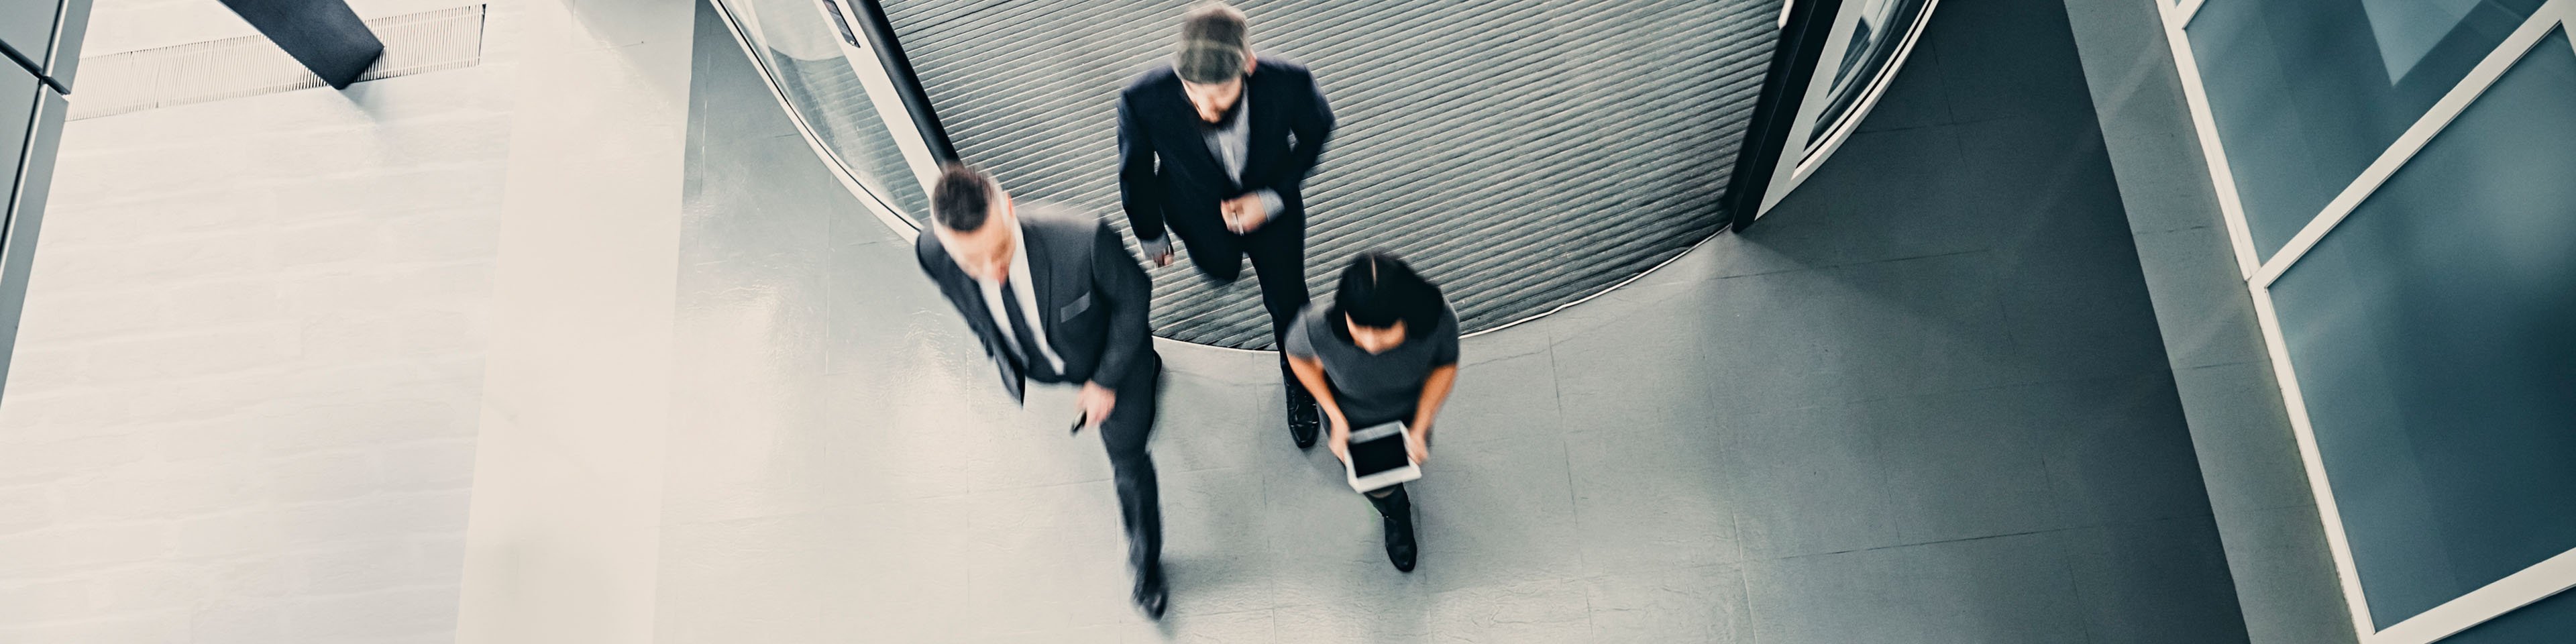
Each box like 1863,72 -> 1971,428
1118,3 -> 1332,448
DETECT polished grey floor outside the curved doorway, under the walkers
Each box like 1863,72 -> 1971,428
657,0 -> 2244,644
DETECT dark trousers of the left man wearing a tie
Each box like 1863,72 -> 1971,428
1040,347 -> 1162,574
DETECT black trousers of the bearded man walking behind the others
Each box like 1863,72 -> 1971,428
1172,211 -> 1309,353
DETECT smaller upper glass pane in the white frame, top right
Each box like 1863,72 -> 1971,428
2187,0 -> 2542,258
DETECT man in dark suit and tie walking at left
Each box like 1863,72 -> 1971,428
914,165 -> 1165,619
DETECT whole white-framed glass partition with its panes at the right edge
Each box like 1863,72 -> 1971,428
2164,0 -> 2576,633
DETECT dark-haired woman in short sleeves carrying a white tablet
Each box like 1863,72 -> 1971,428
1283,252 -> 1458,572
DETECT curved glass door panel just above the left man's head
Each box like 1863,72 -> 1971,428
724,0 -> 930,221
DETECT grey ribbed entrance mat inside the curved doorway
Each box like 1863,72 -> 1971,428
883,0 -> 1780,347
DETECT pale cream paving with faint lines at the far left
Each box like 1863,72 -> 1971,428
0,0 -> 518,644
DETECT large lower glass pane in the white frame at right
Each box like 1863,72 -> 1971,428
2272,34 -> 2576,626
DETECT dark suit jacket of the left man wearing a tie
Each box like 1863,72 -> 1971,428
912,203 -> 1154,399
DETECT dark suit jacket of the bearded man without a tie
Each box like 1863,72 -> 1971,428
1118,59 -> 1332,239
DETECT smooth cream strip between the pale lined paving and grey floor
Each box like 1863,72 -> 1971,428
456,0 -> 696,644
